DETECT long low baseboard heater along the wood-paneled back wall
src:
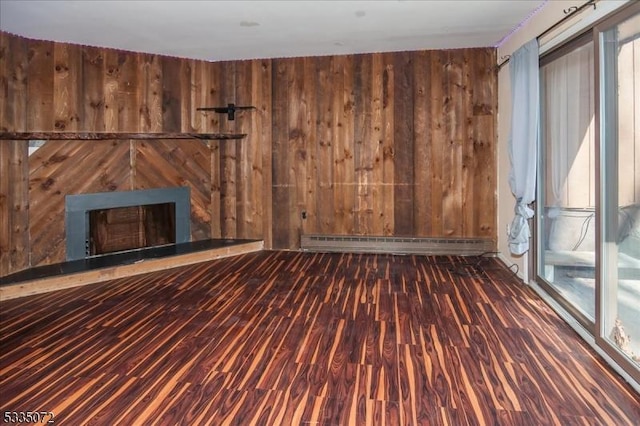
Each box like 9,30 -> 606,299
300,234 -> 495,256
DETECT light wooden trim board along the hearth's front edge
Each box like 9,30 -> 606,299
0,240 -> 264,302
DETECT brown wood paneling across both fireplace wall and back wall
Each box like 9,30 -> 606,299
0,32 -> 497,274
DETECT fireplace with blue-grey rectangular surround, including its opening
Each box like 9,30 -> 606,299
65,187 -> 191,261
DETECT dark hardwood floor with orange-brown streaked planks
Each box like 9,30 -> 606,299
0,251 -> 640,425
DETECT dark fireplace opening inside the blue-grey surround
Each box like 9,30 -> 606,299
87,202 -> 176,256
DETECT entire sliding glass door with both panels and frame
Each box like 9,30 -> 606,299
536,2 -> 640,381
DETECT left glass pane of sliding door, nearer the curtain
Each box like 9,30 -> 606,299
538,42 -> 596,322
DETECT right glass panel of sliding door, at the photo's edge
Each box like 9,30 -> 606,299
601,14 -> 640,366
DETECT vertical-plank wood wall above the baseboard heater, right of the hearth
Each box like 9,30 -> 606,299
273,49 -> 496,247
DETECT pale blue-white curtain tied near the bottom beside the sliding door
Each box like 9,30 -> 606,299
509,39 -> 540,255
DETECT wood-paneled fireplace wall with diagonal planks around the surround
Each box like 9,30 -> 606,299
0,33 -> 271,275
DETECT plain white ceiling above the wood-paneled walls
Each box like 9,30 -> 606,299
0,0 -> 546,61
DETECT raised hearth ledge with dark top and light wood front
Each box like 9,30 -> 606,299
0,240 -> 264,301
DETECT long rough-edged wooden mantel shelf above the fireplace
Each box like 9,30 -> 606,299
0,132 -> 247,140
